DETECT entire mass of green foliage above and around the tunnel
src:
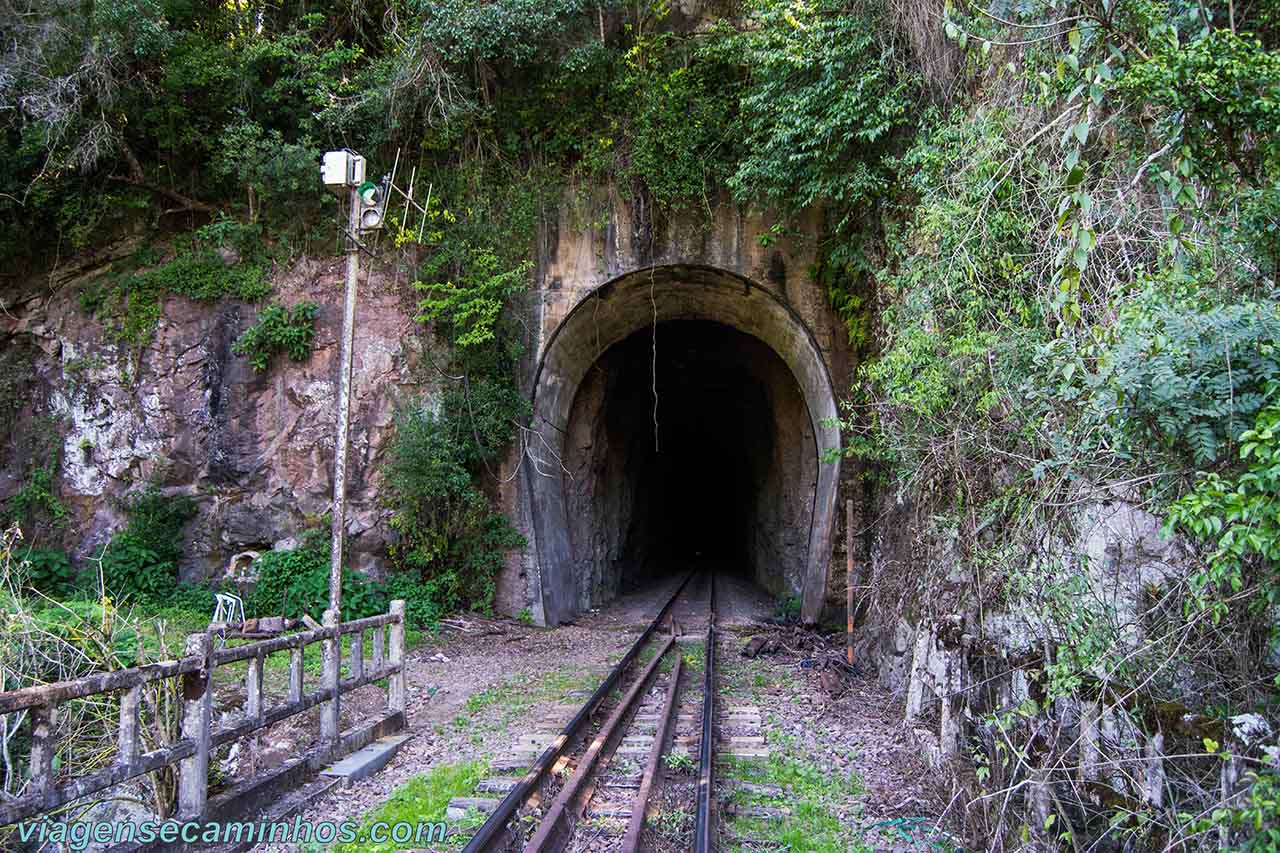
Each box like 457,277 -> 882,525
0,0 -> 1280,849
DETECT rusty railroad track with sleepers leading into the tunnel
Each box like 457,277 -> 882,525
451,574 -> 763,853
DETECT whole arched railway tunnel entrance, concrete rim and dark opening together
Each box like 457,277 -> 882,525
525,265 -> 840,624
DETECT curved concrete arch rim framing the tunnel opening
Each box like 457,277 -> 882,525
525,264 -> 840,625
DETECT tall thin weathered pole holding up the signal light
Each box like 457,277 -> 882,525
329,180 -> 362,615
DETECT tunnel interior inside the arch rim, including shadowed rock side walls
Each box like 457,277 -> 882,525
570,320 -> 812,602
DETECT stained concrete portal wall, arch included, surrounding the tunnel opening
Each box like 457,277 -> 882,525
497,200 -> 851,624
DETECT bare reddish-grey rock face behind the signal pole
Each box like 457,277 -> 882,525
4,252 -> 422,580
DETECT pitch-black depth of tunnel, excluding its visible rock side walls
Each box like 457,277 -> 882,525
608,321 -> 774,585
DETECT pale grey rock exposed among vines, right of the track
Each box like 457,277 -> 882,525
858,485 -> 1190,768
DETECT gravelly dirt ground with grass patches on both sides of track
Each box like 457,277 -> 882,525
247,579 -> 943,853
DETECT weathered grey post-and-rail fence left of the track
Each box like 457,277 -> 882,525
0,601 -> 406,826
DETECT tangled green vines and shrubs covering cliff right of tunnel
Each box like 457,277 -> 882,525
829,1 -> 1280,849
